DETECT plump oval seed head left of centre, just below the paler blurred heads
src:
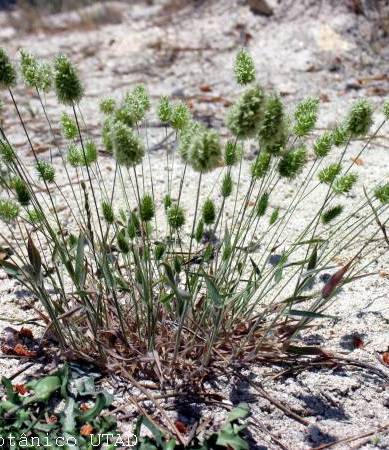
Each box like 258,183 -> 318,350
112,122 -> 144,167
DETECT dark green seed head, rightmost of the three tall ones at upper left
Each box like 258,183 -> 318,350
54,55 -> 84,106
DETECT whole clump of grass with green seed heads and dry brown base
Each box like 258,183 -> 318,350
0,50 -> 389,380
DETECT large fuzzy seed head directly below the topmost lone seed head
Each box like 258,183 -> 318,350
226,85 -> 264,139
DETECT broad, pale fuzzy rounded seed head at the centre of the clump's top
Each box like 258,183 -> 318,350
189,130 -> 221,172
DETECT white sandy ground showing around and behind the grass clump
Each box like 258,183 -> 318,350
0,1 -> 389,450
